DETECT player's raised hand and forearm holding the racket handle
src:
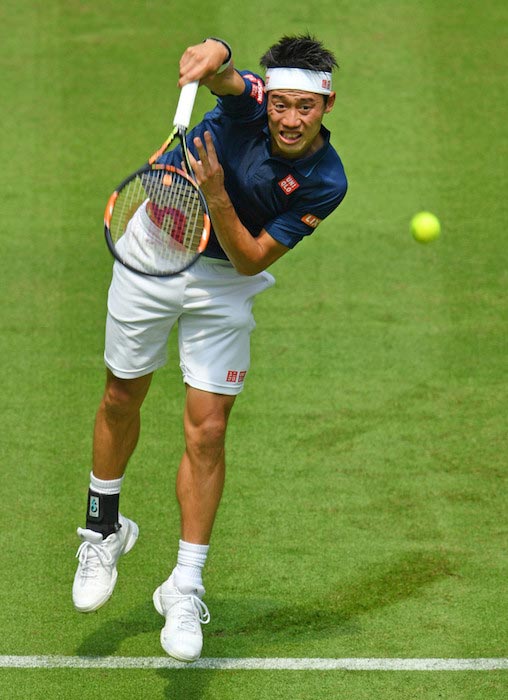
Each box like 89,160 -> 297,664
178,38 -> 245,95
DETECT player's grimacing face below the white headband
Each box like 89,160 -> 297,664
267,90 -> 335,159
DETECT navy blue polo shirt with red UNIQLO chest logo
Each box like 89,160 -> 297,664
161,71 -> 347,259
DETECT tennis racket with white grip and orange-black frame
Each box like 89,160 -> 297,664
104,81 -> 210,277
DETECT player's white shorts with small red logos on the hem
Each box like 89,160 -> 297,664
104,256 -> 275,395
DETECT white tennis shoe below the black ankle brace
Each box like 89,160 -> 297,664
72,515 -> 139,612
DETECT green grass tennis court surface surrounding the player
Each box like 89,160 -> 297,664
0,0 -> 508,700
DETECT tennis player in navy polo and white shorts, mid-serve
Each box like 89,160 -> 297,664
73,35 -> 347,661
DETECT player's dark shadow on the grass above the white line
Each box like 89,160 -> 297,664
76,551 -> 453,656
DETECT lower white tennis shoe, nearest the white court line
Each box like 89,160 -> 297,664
153,576 -> 210,661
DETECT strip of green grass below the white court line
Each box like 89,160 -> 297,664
0,670 -> 506,700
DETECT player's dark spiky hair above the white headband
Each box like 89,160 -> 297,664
259,34 -> 339,73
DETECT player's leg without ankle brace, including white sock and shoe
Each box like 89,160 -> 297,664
153,386 -> 235,661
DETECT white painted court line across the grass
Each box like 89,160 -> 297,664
0,656 -> 508,671
